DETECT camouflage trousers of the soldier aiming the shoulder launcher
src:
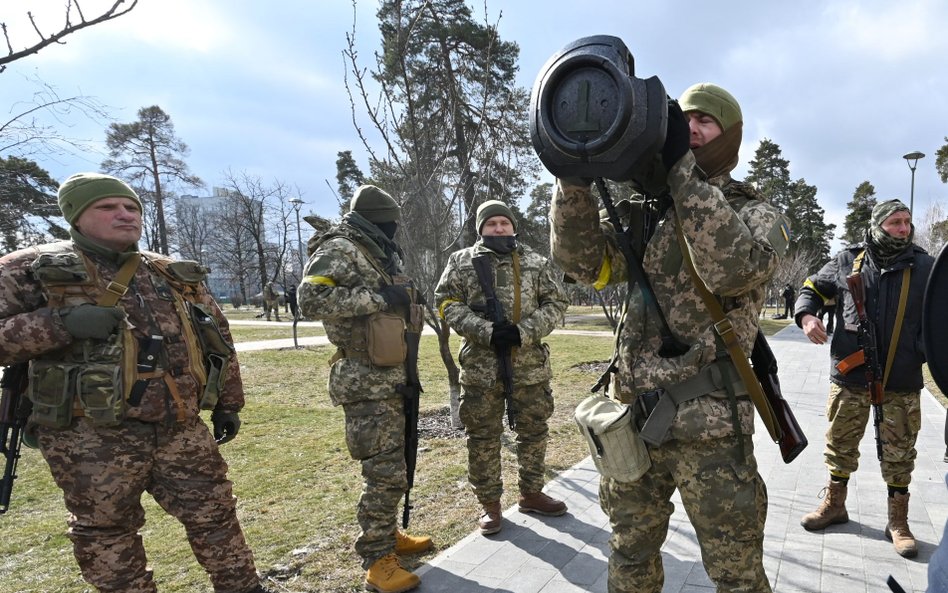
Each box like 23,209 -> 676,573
599,436 -> 771,593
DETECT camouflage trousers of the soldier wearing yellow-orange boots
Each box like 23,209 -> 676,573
342,397 -> 408,569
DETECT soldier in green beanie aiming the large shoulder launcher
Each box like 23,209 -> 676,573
550,83 -> 790,593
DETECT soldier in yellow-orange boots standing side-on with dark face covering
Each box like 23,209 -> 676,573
297,185 -> 432,593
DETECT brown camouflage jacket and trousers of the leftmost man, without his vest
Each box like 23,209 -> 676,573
0,241 -> 258,593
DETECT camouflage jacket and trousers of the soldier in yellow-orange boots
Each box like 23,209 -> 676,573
297,212 -> 408,569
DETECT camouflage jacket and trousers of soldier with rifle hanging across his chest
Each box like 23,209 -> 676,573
435,240 -> 569,504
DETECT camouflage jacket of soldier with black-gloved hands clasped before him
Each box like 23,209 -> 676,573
435,241 -> 569,388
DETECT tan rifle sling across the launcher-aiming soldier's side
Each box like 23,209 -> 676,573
675,223 -> 782,443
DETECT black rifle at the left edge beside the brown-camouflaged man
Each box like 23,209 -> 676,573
0,362 -> 29,514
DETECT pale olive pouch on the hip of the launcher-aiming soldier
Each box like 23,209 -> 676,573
574,394 -> 652,482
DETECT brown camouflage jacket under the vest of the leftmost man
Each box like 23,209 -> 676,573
0,241 -> 244,422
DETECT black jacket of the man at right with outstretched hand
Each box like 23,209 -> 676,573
794,243 -> 935,391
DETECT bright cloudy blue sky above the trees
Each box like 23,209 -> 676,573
0,0 -> 948,251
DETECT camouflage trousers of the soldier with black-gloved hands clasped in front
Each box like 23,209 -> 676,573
459,383 -> 553,504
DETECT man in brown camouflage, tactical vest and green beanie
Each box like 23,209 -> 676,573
0,173 -> 267,593
